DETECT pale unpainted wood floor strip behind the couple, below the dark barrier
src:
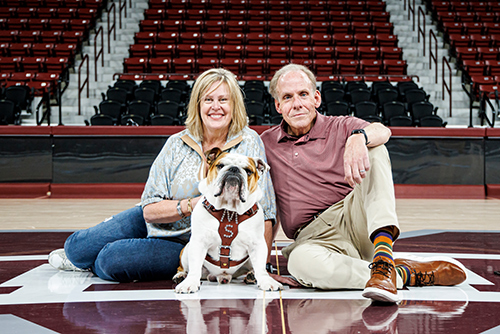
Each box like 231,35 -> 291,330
0,198 -> 500,237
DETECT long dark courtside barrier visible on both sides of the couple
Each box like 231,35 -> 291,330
0,127 -> 492,185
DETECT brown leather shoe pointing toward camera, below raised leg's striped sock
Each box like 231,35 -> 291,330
363,256 -> 399,303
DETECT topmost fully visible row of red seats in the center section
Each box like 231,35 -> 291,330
145,9 -> 390,22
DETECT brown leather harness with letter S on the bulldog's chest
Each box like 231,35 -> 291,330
203,199 -> 259,269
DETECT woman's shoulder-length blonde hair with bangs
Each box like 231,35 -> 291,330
186,68 -> 248,141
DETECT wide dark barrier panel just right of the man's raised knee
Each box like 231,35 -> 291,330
387,138 -> 484,185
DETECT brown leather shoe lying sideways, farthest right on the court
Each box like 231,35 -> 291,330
394,256 -> 467,286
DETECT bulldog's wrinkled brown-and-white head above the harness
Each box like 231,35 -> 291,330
200,148 -> 269,211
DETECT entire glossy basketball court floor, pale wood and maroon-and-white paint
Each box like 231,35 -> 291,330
0,199 -> 500,334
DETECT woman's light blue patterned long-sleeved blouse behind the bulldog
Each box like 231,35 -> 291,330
141,127 -> 276,241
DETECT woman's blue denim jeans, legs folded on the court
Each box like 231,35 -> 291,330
64,206 -> 184,282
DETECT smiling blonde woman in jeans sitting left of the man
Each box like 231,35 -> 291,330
49,69 -> 276,282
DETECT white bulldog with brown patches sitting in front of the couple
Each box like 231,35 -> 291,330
173,148 -> 283,293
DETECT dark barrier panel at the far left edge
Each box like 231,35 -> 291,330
0,135 -> 52,182
